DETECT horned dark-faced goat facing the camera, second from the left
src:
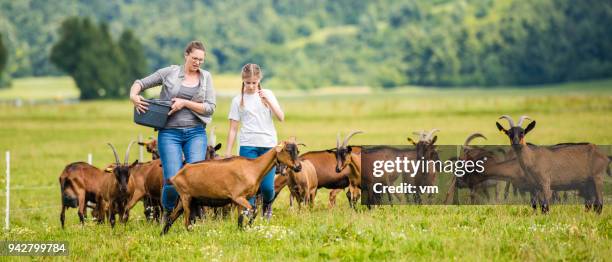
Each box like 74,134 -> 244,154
98,141 -> 137,227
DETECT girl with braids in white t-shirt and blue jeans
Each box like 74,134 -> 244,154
225,64 -> 285,220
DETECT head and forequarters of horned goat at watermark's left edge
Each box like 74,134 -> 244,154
335,131 -> 363,208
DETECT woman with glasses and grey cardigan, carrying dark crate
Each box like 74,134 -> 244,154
130,41 -> 216,215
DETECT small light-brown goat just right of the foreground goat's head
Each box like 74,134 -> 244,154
281,160 -> 318,208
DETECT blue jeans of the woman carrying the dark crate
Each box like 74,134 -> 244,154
157,125 -> 207,211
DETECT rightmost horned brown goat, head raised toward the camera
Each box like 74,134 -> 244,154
496,115 -> 609,213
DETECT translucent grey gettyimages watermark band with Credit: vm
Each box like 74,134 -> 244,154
361,143 -> 612,205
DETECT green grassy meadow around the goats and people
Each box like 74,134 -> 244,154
0,77 -> 612,261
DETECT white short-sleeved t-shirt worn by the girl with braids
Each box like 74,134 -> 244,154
228,89 -> 278,147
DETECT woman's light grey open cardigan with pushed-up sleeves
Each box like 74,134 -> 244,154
136,65 -> 217,124
